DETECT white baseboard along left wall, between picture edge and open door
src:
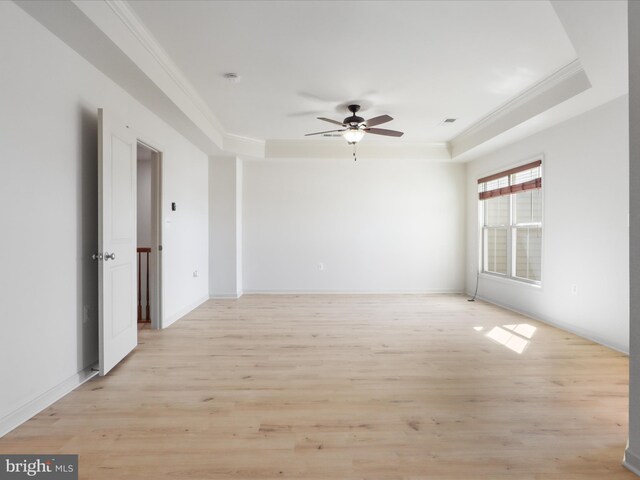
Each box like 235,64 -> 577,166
0,364 -> 98,437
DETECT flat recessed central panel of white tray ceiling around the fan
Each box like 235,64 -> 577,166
129,0 -> 577,142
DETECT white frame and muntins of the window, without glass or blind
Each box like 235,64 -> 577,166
477,155 -> 546,288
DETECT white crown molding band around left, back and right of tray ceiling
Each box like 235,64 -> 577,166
56,0 -> 591,161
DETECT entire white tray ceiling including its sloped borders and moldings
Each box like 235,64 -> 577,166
17,0 -> 628,161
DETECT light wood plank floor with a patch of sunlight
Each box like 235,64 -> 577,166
0,295 -> 637,480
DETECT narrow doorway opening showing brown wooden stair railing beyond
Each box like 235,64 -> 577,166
136,141 -> 162,329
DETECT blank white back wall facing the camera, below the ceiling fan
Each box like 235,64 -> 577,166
243,158 -> 465,293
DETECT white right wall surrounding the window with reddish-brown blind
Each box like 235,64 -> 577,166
466,96 -> 629,351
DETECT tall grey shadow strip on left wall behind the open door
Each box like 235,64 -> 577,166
76,105 -> 98,371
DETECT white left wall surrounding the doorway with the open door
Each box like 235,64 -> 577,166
0,2 -> 208,429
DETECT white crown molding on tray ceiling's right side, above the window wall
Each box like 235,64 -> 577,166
450,59 -> 591,158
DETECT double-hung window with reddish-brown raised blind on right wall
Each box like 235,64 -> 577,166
478,160 -> 542,284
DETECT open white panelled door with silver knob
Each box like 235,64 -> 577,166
98,108 -> 138,375
